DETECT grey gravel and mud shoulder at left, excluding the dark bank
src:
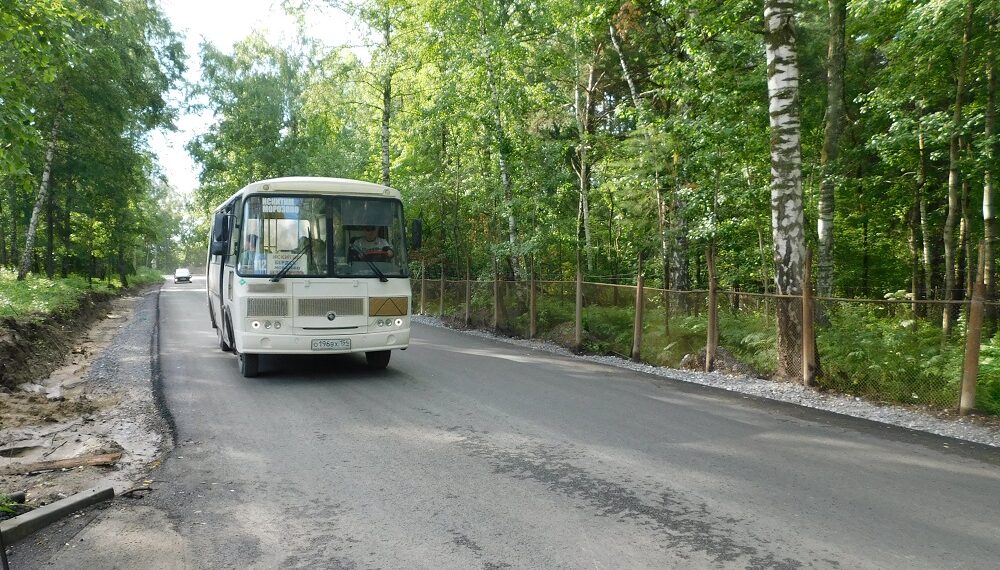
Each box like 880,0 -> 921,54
0,287 -> 172,507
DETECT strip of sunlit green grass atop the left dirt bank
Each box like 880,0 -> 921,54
0,268 -> 163,318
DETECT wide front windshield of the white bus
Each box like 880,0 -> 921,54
237,194 -> 408,277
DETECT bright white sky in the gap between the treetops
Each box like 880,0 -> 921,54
150,0 -> 359,193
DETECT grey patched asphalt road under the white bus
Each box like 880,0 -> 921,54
9,279 -> 1000,569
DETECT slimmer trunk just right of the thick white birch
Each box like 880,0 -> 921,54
816,0 -> 847,296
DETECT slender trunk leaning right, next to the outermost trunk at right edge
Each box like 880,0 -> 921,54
941,0 -> 974,335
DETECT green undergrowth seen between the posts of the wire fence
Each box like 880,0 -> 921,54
438,282 -> 1000,415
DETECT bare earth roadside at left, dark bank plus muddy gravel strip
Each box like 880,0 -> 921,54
0,287 -> 166,510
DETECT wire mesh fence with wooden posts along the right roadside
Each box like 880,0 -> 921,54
414,272 -> 1000,414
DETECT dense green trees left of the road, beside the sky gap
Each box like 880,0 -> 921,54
0,0 -> 184,281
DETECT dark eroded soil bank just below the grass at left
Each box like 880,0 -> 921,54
0,293 -> 114,388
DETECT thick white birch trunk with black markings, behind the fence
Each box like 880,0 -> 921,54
764,0 -> 805,379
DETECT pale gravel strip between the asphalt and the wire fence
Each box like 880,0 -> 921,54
412,315 -> 1000,447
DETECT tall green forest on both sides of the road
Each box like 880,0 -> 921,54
0,0 -> 1000,408
